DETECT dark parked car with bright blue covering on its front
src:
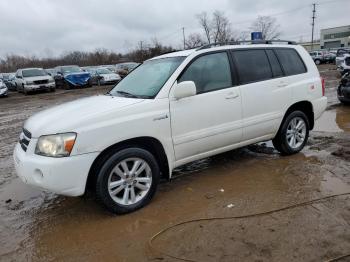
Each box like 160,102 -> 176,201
54,65 -> 92,89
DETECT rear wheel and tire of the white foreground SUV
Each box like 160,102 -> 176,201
272,111 -> 310,155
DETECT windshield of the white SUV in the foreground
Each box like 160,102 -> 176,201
109,57 -> 185,98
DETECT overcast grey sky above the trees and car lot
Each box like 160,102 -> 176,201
0,0 -> 350,57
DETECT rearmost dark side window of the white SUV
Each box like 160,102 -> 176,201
275,48 -> 306,76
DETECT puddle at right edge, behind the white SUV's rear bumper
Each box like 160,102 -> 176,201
314,105 -> 350,132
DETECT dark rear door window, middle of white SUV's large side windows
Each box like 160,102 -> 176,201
232,49 -> 272,84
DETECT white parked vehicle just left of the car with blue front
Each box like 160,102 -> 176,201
15,68 -> 56,95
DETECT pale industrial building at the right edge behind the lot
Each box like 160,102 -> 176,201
320,25 -> 350,49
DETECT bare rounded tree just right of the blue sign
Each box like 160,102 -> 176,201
251,16 -> 281,40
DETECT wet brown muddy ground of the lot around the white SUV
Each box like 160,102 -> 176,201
0,66 -> 350,261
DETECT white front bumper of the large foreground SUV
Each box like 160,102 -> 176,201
13,142 -> 98,196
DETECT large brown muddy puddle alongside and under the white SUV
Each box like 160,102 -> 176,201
0,149 -> 334,261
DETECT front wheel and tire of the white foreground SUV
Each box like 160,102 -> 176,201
96,147 -> 160,214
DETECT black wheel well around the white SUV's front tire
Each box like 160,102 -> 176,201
86,137 -> 169,190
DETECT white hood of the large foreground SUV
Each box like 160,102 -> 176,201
24,95 -> 144,137
